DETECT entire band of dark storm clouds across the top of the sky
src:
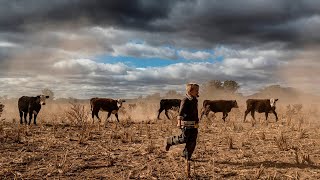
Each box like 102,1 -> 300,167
0,0 -> 320,47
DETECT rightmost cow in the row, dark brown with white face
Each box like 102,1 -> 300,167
243,98 -> 278,122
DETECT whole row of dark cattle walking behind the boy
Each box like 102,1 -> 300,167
0,95 -> 278,125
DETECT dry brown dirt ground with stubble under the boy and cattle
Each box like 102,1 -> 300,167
0,104 -> 320,179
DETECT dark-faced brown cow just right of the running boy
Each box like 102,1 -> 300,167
200,100 -> 238,121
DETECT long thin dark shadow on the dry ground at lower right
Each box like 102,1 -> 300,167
216,161 -> 320,169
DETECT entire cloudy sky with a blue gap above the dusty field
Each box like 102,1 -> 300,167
0,0 -> 320,98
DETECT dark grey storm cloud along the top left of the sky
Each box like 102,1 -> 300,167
0,0 -> 174,31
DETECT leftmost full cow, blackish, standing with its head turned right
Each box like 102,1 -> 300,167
18,95 -> 49,125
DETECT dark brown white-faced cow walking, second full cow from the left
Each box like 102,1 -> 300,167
90,97 -> 126,123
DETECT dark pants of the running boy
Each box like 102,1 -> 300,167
167,128 -> 198,160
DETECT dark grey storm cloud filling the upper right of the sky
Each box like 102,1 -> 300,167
163,0 -> 320,46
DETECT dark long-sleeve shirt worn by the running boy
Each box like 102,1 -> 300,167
178,95 -> 199,122
